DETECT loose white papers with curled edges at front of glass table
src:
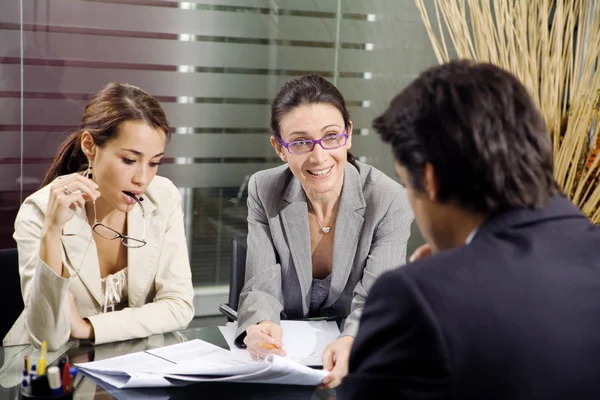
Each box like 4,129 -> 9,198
76,339 -> 327,389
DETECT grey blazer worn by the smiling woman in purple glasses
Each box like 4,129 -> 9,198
236,163 -> 413,336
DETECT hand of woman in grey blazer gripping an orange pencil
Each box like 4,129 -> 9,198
244,321 -> 286,360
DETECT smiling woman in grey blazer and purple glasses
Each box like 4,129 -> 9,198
237,75 -> 413,388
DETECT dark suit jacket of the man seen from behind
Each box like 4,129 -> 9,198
338,196 -> 600,400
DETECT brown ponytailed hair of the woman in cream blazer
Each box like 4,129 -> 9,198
42,83 -> 171,187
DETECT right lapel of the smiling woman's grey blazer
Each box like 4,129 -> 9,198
326,163 -> 366,307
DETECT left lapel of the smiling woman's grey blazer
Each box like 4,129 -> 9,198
281,178 -> 312,314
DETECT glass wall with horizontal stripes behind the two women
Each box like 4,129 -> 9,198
0,0 -> 433,286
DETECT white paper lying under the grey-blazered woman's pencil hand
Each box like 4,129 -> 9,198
219,321 -> 340,367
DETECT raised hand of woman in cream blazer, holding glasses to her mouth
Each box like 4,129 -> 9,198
44,173 -> 100,232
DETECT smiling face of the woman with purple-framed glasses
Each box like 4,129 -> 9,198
271,103 -> 352,196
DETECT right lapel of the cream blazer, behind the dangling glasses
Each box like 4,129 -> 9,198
127,194 -> 158,307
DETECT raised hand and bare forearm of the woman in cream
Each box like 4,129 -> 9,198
40,173 -> 100,276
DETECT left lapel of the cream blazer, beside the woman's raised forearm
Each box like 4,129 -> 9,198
60,208 -> 104,304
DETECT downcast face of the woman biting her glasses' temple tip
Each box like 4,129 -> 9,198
82,121 -> 167,212
